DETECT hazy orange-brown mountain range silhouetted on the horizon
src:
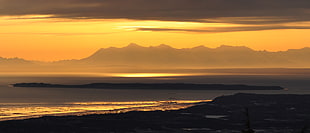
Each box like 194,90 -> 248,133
0,44 -> 310,69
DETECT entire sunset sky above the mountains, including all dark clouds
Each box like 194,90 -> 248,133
0,0 -> 310,61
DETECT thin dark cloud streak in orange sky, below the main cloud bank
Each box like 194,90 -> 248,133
136,26 -> 310,33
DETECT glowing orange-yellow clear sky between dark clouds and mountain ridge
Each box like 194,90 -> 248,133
0,16 -> 310,61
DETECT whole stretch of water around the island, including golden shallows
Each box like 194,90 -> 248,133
0,73 -> 310,121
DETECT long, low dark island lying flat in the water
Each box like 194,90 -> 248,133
13,83 -> 284,90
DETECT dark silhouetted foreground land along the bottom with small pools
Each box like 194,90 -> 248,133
0,93 -> 310,133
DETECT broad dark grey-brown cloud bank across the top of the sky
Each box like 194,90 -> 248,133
0,0 -> 310,24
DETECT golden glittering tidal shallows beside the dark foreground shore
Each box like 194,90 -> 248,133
0,100 -> 210,121
